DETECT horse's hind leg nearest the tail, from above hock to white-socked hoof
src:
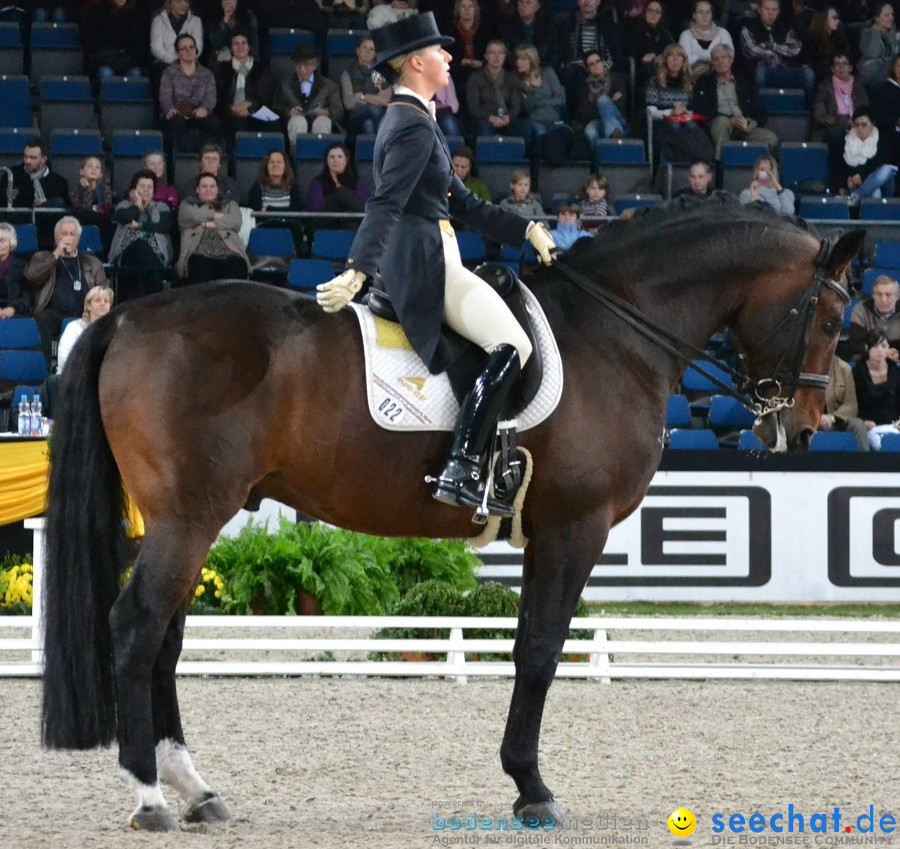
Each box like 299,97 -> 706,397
110,527 -> 229,831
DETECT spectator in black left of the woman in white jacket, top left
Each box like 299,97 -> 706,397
81,0 -> 148,79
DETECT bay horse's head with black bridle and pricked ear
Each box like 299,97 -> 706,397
734,225 -> 865,451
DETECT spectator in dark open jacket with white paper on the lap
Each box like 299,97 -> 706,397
215,29 -> 278,144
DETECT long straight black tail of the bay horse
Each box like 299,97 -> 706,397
41,315 -> 127,749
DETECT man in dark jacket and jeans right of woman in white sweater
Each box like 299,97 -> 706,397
740,0 -> 816,104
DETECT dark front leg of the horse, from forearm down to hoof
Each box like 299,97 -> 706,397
500,519 -> 609,824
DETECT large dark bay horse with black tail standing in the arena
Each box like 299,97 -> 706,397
42,203 -> 864,830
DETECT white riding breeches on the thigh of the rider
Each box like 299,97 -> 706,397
441,229 -> 531,366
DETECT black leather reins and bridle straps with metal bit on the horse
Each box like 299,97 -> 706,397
554,239 -> 850,418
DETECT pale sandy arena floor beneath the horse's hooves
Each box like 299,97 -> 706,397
0,678 -> 900,849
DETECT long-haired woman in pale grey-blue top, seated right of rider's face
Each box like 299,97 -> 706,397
515,44 -> 573,165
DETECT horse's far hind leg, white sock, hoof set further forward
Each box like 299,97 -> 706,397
152,605 -> 231,823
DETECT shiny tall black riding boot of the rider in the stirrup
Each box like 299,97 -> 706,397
434,345 -> 520,516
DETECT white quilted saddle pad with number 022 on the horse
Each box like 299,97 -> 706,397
350,286 -> 563,431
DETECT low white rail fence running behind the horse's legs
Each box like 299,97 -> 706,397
0,616 -> 900,683
